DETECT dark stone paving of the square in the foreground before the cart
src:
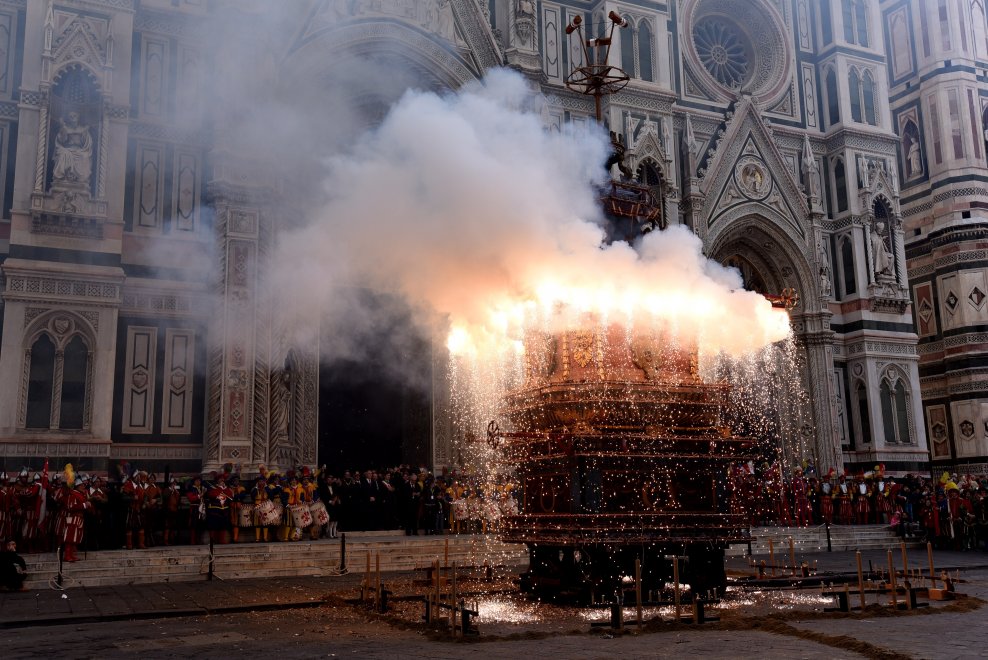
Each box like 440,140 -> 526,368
0,552 -> 988,660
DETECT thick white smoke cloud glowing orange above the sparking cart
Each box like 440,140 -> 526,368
273,70 -> 788,364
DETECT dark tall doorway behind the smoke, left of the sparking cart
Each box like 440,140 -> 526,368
319,289 -> 432,474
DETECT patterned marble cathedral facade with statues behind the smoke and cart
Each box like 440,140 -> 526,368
0,0 -> 988,473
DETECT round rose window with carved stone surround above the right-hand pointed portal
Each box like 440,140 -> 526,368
684,0 -> 791,103
